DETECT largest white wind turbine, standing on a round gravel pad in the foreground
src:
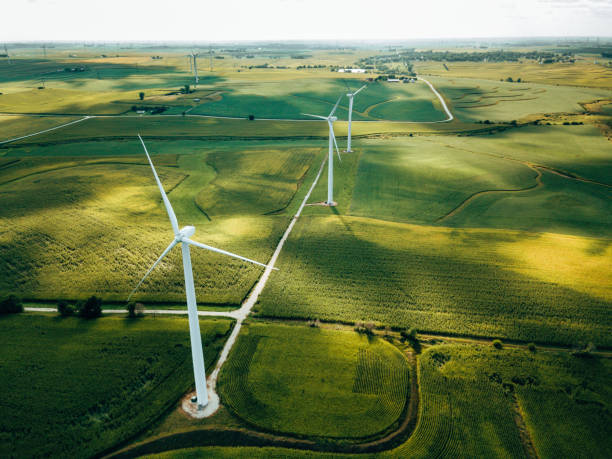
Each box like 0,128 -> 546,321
128,134 -> 277,409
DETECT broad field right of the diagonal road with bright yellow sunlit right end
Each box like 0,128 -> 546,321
257,215 -> 612,345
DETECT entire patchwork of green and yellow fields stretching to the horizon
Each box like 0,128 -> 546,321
0,46 -> 612,458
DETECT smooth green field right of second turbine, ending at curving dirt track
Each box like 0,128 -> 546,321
350,137 -> 536,224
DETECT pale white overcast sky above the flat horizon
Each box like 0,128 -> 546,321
0,0 -> 612,42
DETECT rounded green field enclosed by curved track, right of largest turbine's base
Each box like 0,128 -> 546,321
219,323 -> 410,438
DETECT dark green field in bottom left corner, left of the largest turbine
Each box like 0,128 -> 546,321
0,315 -> 230,457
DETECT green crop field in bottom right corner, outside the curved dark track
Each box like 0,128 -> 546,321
390,346 -> 612,458
